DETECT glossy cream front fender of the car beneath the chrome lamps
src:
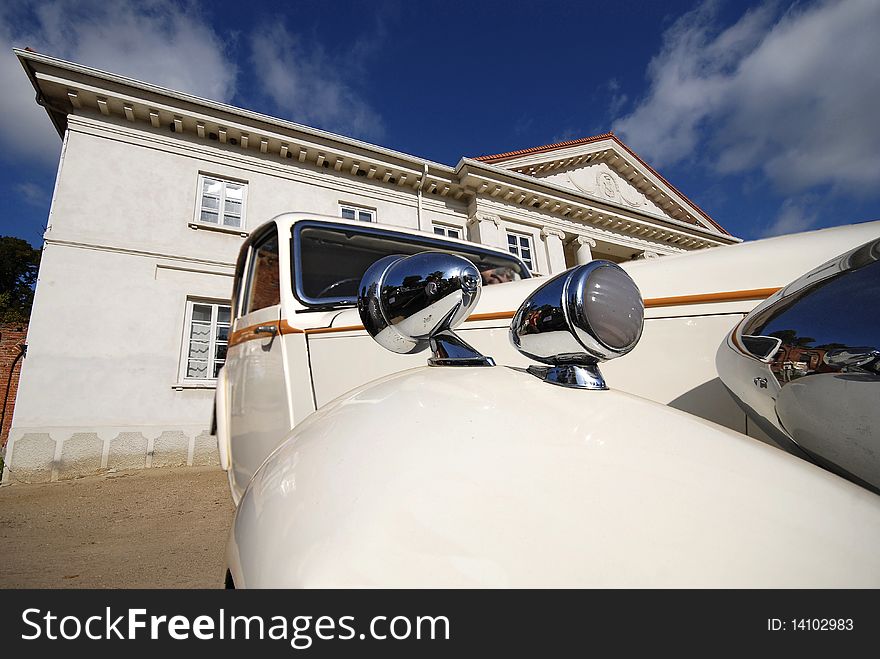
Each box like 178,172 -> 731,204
227,366 -> 880,587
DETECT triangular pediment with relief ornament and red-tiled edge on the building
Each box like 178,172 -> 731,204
478,134 -> 727,233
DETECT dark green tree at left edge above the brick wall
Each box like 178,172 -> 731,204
0,236 -> 40,323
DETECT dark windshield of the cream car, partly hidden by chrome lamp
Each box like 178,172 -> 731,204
292,221 -> 529,306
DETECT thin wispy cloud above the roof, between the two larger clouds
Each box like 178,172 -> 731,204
250,21 -> 385,140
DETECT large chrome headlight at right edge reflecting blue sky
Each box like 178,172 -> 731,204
717,240 -> 880,491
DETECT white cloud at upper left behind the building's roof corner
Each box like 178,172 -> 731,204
0,0 -> 237,162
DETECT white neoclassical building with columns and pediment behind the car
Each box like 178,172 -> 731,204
3,45 -> 738,482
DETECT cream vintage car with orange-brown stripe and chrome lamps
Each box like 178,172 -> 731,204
215,214 -> 880,588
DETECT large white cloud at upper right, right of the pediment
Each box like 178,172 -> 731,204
614,0 -> 880,196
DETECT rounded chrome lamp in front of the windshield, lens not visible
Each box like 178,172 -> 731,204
358,252 -> 495,366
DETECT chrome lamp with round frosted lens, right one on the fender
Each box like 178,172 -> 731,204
510,261 -> 644,389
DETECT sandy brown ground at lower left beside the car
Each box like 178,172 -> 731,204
0,467 -> 233,588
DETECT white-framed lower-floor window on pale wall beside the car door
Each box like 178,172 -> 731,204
180,300 -> 230,381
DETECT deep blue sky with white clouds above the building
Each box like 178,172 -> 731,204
0,0 -> 880,245
